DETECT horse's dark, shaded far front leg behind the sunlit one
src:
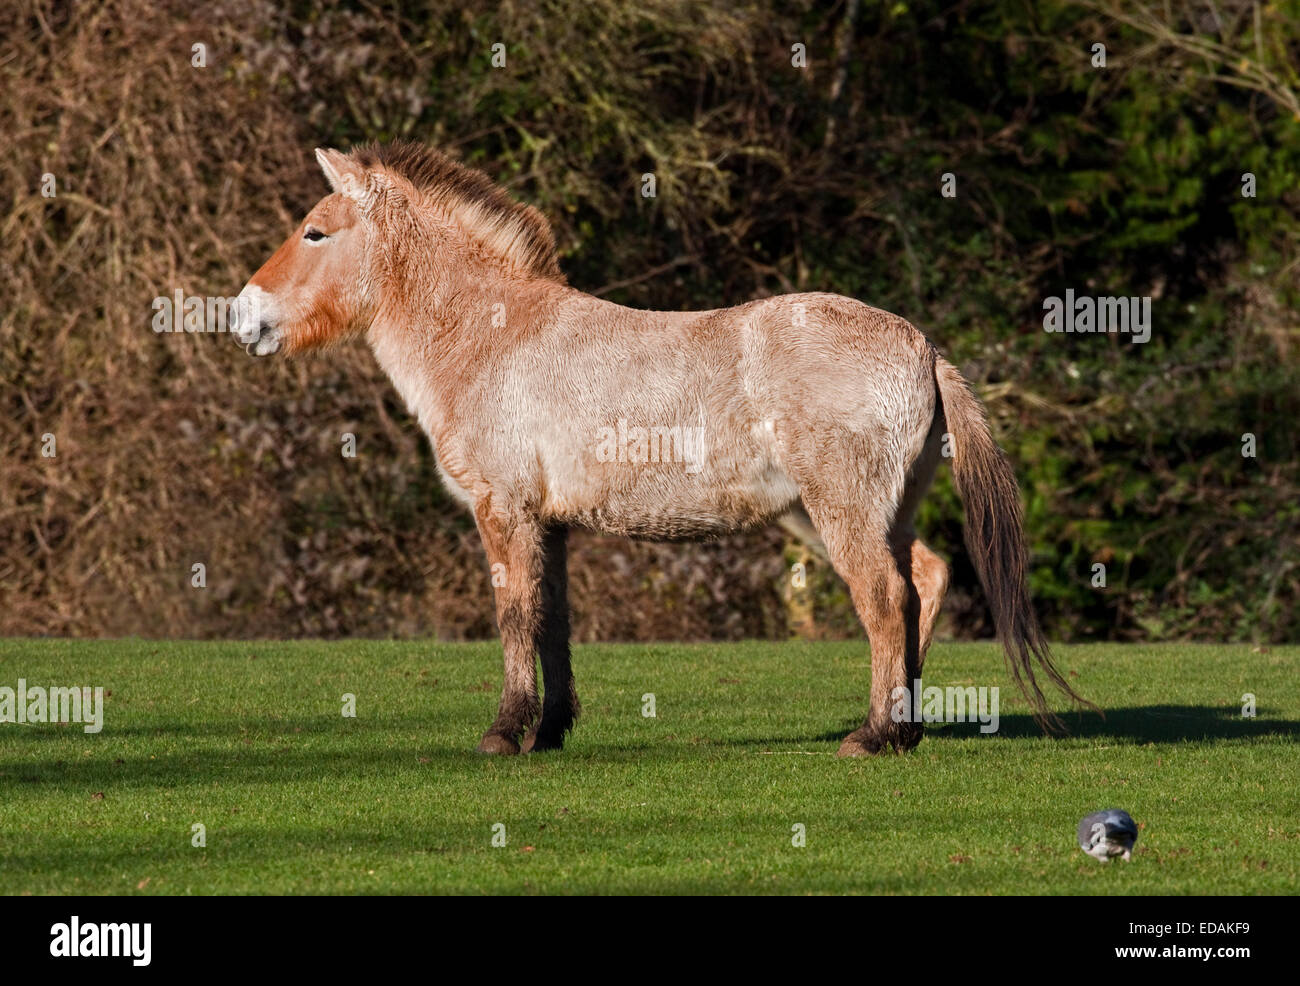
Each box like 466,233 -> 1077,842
523,527 -> 579,753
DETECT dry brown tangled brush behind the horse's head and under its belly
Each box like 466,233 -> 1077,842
0,0 -> 784,640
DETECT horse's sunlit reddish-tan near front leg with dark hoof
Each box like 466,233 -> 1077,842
475,497 -> 543,753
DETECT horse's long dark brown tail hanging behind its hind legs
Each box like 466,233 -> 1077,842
935,354 -> 1100,732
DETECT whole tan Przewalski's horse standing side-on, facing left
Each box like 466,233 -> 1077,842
231,143 -> 1078,756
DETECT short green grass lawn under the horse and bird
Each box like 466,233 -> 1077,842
0,640 -> 1300,894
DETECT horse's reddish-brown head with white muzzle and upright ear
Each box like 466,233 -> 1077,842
229,150 -> 386,356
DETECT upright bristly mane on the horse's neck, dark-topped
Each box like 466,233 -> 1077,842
352,140 -> 564,281
